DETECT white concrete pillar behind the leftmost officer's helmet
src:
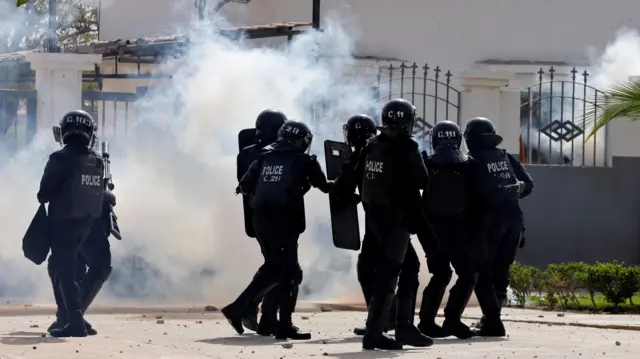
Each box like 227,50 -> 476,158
25,53 -> 102,127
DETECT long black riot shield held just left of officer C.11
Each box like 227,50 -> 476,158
324,140 -> 360,251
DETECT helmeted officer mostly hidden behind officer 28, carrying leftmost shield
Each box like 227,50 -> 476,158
237,109 -> 288,336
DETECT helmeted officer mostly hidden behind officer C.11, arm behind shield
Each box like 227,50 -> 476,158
336,115 -> 433,347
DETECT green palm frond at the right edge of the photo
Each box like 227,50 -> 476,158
582,82 -> 640,141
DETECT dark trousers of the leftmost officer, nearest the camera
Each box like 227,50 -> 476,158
48,218 -> 93,323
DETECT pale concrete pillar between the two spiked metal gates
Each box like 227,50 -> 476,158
460,70 -> 520,153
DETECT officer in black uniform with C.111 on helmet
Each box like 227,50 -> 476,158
418,121 -> 498,339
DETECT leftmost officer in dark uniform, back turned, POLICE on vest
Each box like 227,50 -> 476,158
38,110 -> 104,337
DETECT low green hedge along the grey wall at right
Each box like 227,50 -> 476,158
510,261 -> 640,311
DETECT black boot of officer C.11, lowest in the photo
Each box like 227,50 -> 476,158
362,294 -> 402,350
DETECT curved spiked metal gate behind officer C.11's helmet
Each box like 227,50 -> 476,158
371,62 -> 461,151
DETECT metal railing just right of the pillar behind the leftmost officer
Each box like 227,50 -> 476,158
82,91 -> 140,138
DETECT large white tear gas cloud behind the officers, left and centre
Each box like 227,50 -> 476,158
0,9 -> 380,303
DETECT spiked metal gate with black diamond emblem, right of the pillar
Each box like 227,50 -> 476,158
520,66 -> 608,166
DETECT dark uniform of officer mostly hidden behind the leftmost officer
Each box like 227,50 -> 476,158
47,191 -> 116,335
